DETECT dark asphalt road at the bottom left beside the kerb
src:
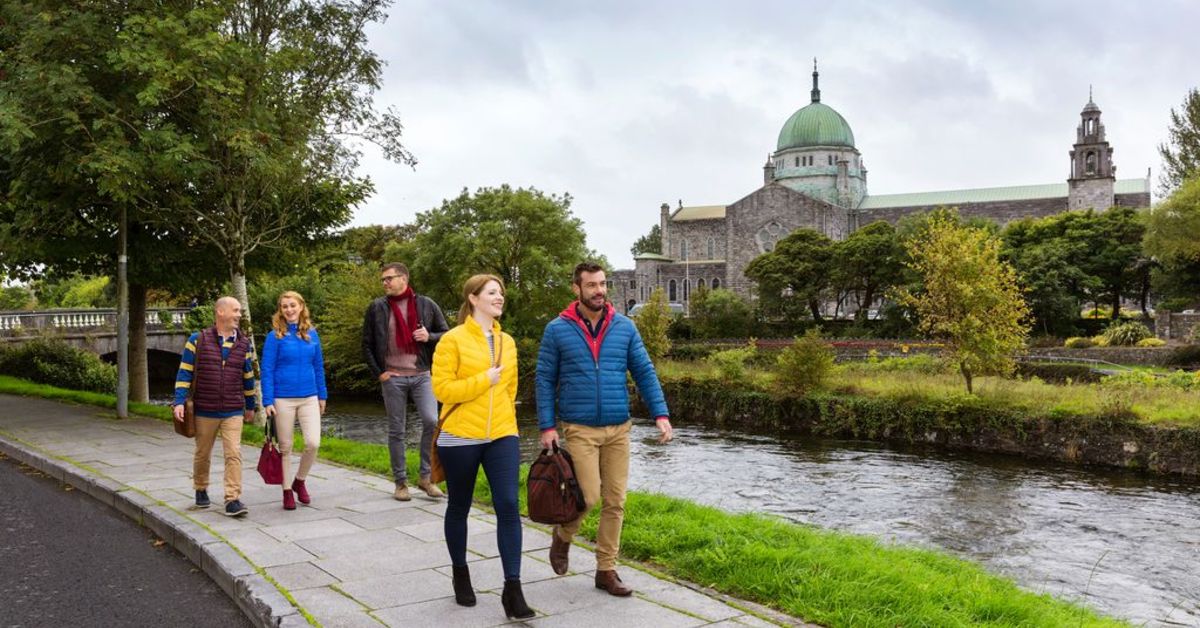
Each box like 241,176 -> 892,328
0,455 -> 251,628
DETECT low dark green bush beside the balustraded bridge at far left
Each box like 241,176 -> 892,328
0,339 -> 116,394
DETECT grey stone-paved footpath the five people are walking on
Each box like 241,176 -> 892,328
0,395 -> 799,628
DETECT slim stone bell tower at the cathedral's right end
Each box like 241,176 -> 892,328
1067,89 -> 1117,211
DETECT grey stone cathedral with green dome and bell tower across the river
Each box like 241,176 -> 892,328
608,67 -> 1150,311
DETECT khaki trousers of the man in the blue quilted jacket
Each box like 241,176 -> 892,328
558,421 -> 629,570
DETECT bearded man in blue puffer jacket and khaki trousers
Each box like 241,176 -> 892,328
538,262 -> 671,597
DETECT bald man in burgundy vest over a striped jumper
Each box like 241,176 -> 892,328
174,297 -> 254,516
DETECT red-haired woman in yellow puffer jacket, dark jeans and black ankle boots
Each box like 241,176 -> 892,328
432,275 -> 534,618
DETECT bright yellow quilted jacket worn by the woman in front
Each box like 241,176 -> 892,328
432,318 -> 517,441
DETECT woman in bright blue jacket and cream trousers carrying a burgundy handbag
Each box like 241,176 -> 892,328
262,291 -> 329,510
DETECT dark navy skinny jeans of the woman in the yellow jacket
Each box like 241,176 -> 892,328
438,436 -> 521,580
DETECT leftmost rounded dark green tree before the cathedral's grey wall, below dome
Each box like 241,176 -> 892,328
745,228 -> 834,321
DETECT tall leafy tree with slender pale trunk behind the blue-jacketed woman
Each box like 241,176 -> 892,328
110,0 -> 415,336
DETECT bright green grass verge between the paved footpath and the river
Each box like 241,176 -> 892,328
0,376 -> 1126,627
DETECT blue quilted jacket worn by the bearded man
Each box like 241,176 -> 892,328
536,301 -> 667,430
